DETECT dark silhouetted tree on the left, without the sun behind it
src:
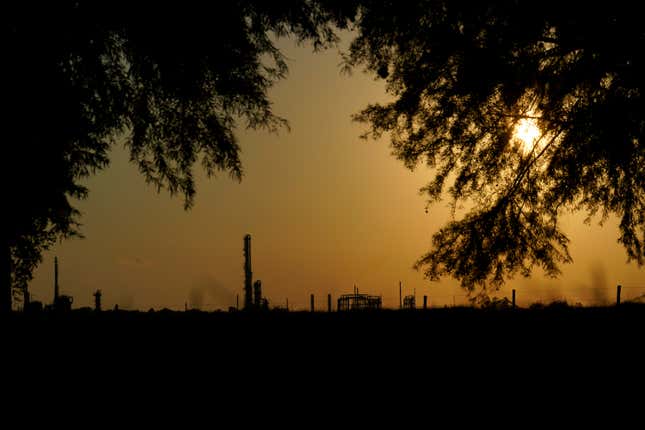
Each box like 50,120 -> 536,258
0,0 -> 355,311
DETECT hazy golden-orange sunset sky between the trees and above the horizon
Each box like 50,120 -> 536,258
30,33 -> 645,310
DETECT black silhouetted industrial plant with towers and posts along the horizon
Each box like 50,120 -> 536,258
13,234 -> 645,333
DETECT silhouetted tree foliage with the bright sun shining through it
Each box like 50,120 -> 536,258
347,0 -> 645,291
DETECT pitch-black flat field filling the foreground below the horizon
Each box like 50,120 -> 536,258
0,305 -> 645,417
